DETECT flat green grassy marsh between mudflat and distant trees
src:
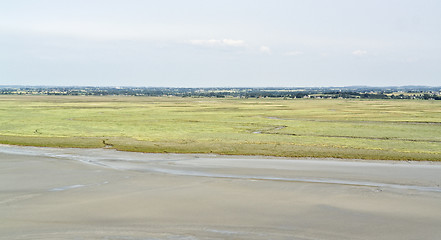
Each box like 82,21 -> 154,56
0,96 -> 441,161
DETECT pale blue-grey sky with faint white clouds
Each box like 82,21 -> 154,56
0,0 -> 441,87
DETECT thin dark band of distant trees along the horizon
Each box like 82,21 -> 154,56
0,86 -> 441,100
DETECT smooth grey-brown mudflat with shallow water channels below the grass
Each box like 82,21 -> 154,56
0,145 -> 441,240
